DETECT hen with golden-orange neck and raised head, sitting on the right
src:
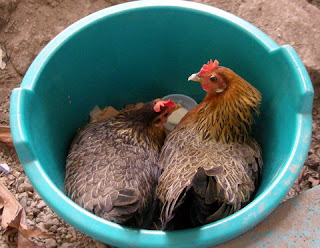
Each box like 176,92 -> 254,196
157,60 -> 262,229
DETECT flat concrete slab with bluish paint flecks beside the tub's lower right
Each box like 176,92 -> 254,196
215,186 -> 320,248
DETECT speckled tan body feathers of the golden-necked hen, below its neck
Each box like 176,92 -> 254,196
157,128 -> 261,228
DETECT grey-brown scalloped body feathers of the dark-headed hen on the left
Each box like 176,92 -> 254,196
65,121 -> 159,228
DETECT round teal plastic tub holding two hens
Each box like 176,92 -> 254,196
10,0 -> 313,248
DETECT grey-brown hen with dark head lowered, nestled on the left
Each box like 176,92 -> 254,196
65,99 -> 176,228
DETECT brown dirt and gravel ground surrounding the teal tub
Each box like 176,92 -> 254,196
0,0 -> 320,248
